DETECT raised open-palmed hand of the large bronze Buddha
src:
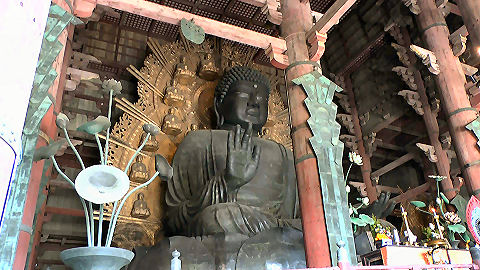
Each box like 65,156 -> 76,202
225,123 -> 260,192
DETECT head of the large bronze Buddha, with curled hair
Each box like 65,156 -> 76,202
214,66 -> 270,133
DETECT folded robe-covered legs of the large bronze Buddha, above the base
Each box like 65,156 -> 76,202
188,202 -> 279,236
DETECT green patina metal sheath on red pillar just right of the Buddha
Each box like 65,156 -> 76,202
293,71 -> 356,265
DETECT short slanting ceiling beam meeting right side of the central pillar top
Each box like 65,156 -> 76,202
307,0 -> 357,37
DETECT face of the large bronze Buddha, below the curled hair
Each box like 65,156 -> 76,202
217,80 -> 268,131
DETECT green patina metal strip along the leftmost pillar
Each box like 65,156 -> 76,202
0,4 -> 83,269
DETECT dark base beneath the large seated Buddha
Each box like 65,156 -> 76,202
128,228 -> 306,270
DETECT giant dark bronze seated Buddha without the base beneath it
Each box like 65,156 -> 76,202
166,67 -> 296,236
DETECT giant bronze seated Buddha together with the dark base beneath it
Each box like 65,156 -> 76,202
129,66 -> 305,269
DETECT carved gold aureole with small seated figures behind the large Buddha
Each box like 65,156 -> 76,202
106,39 -> 292,249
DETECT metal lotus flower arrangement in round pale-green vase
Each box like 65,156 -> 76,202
34,79 -> 173,270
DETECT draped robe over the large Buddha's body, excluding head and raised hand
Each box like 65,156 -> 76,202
166,130 -> 298,236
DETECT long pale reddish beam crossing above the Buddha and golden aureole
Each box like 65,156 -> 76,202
97,0 -> 287,51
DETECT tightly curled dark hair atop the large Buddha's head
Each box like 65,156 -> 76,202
215,66 -> 270,103
